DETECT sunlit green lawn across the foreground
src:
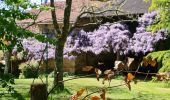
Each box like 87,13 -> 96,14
0,78 -> 170,100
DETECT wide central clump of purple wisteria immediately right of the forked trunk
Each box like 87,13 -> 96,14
64,23 -> 130,60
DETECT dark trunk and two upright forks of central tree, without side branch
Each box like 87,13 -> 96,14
50,0 -> 72,91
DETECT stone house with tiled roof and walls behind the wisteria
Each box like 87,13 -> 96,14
18,0 -> 150,73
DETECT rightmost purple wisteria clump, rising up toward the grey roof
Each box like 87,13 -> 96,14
126,11 -> 167,55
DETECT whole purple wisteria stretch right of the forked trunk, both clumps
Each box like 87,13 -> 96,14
64,11 -> 167,60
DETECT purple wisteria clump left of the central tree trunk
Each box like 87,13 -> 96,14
17,38 -> 55,61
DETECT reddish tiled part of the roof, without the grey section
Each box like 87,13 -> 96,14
18,0 -> 103,24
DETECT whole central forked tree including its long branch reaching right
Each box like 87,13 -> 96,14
50,0 -> 126,91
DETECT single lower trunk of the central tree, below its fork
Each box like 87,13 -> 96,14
54,41 -> 64,92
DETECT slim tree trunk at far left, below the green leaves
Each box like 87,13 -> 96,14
4,51 -> 11,74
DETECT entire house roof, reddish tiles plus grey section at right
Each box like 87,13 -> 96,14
18,0 -> 151,24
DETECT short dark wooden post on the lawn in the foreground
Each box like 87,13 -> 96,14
30,84 -> 48,100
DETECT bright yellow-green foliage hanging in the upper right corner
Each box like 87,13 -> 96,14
145,0 -> 170,33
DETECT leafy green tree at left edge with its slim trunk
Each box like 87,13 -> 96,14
0,0 -> 41,74
